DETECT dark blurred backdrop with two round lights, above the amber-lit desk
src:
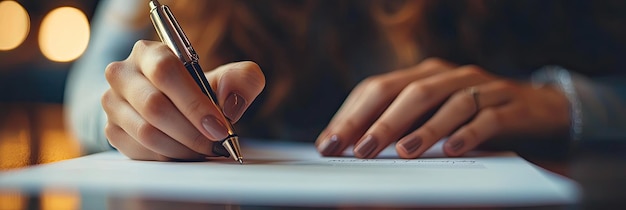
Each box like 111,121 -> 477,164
0,0 -> 98,103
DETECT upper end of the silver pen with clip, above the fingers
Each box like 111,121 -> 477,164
150,0 -> 198,64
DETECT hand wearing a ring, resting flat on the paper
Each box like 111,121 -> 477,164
316,58 -> 570,158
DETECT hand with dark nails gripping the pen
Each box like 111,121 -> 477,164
102,41 -> 265,161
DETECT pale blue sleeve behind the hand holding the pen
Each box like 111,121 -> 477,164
64,0 -> 150,154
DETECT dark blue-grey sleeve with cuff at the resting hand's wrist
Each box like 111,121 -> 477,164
533,66 -> 626,142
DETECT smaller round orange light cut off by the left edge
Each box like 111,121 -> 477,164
0,1 -> 30,50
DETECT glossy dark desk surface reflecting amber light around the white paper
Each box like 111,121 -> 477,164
0,104 -> 626,209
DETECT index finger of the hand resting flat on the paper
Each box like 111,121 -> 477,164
317,59 -> 454,156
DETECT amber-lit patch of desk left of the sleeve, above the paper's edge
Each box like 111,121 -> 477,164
0,103 -> 80,170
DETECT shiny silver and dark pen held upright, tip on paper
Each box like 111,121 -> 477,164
149,0 -> 243,164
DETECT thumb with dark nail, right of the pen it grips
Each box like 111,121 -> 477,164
205,61 -> 265,123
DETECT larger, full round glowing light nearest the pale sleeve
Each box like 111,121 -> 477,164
39,7 -> 89,62
